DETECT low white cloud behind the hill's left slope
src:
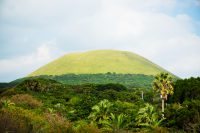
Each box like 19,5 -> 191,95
0,42 -> 63,81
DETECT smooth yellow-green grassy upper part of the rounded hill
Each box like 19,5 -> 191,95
29,50 -> 170,76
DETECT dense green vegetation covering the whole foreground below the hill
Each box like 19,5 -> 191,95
0,75 -> 200,133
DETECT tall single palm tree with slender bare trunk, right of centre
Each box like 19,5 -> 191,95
153,73 -> 174,113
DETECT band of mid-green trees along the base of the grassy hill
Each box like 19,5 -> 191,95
10,72 -> 154,88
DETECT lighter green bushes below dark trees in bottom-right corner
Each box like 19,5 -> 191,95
165,100 -> 200,133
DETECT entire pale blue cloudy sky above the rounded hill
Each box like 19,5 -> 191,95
0,0 -> 200,82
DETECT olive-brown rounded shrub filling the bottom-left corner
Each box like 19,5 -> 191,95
0,106 -> 46,133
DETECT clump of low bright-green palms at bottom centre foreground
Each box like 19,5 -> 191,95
88,99 -> 128,132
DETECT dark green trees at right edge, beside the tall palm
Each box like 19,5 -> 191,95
165,77 -> 200,133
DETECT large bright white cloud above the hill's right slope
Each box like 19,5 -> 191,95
69,2 -> 200,77
